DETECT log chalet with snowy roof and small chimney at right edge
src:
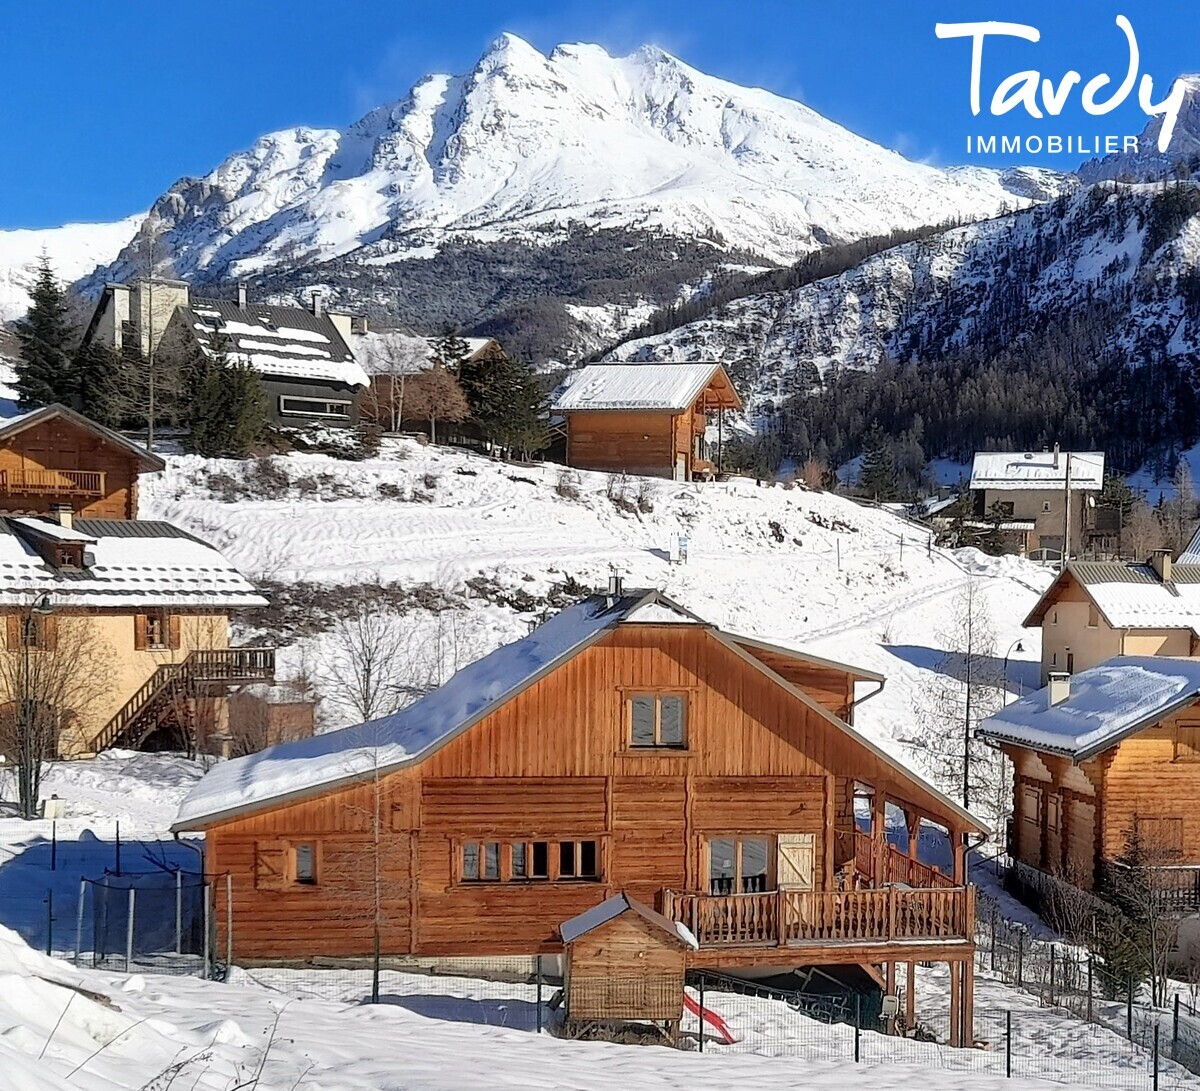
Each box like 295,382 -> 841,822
979,655 -> 1200,910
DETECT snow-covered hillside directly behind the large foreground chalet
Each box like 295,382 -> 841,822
142,440 -> 1051,756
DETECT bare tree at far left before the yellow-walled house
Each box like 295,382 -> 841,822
0,597 -> 113,819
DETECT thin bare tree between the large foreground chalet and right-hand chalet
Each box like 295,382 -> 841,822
904,580 -> 1010,817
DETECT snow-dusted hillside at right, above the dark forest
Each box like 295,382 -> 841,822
610,184 -> 1200,416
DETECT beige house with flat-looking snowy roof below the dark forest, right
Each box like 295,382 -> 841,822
971,444 -> 1104,559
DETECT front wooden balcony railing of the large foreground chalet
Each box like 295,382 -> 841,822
662,886 -> 974,947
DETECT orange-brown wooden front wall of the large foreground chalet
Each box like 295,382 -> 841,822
208,624 -> 974,959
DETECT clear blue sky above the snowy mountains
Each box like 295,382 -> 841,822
0,0 -> 1200,227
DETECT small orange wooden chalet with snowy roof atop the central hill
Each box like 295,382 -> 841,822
552,364 -> 742,481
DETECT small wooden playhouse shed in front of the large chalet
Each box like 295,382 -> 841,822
559,892 -> 697,1032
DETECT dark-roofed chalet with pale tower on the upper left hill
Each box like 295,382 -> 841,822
84,280 -> 368,426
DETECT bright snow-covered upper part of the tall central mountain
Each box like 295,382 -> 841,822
93,34 -> 1060,289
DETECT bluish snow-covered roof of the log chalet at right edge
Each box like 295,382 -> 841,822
979,655 -> 1200,761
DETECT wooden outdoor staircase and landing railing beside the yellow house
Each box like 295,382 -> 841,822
92,648 -> 275,753
